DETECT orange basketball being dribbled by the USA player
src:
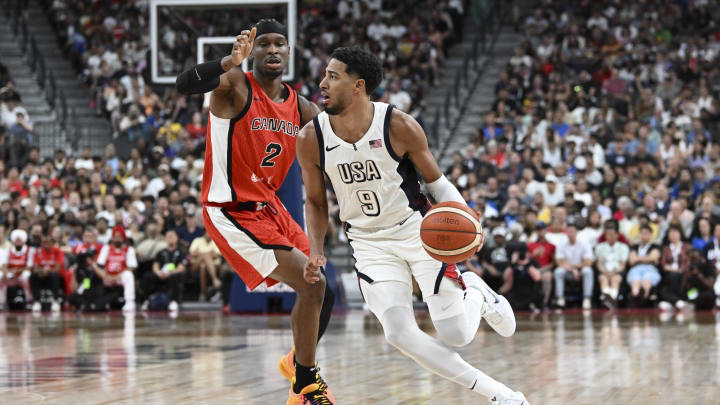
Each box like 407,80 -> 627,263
420,201 -> 485,264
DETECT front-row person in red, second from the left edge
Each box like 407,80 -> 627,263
30,232 -> 65,312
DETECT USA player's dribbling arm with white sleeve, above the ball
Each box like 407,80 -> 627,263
390,109 -> 465,204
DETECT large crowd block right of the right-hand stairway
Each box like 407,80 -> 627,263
456,0 -> 720,311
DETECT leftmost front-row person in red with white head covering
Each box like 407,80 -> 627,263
0,229 -> 33,307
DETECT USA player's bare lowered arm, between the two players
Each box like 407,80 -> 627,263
296,123 -> 328,284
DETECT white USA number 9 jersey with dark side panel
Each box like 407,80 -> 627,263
313,103 -> 430,228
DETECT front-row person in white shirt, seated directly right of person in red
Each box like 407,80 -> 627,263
554,223 -> 594,309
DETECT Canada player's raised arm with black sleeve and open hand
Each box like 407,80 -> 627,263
175,27 -> 257,94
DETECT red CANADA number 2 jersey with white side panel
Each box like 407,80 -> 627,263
202,72 -> 300,203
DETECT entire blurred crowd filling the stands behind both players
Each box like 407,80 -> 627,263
0,0 -> 720,311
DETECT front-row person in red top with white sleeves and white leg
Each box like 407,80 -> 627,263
96,225 -> 137,312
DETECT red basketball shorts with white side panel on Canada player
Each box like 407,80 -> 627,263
203,196 -> 310,290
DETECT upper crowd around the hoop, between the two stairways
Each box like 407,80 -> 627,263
44,0 -> 467,153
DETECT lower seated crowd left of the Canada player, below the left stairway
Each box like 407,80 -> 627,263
0,140 -> 234,311
